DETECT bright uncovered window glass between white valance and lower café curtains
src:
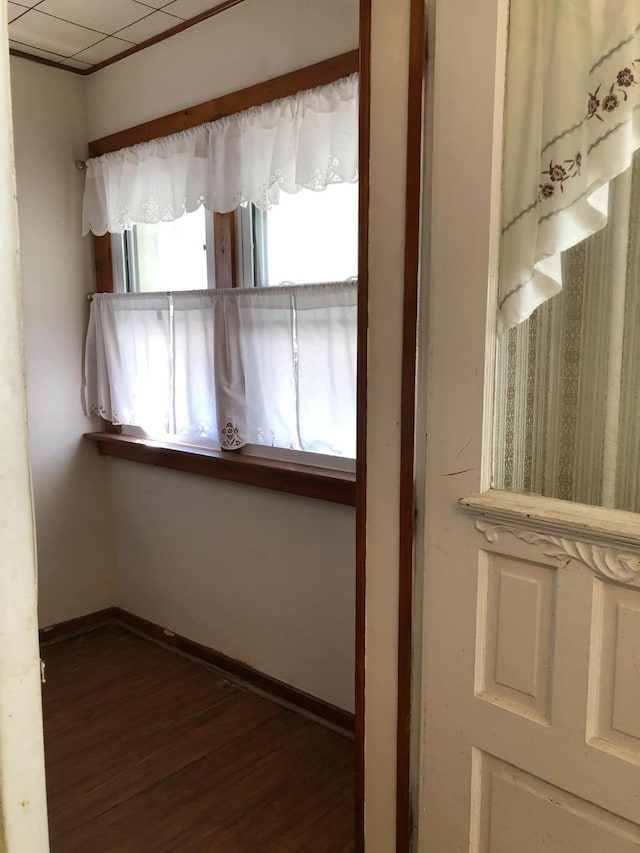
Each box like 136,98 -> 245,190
112,182 -> 358,293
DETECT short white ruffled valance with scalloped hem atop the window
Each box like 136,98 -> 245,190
83,74 -> 358,234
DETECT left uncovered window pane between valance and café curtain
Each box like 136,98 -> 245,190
128,207 -> 213,293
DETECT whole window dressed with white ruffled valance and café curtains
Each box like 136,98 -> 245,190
83,55 -> 358,492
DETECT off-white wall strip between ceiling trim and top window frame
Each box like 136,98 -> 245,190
87,0 -> 358,139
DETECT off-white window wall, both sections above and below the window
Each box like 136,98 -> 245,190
87,0 -> 358,710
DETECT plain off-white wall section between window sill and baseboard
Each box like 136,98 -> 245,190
112,461 -> 355,709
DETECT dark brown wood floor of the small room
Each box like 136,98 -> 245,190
43,626 -> 354,853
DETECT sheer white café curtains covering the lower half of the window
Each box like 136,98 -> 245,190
85,282 -> 357,457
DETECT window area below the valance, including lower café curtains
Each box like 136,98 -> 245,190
102,193 -> 358,467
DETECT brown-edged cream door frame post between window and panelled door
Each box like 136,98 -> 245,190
355,0 -> 426,853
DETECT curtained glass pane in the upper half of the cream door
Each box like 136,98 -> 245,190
494,3 -> 640,512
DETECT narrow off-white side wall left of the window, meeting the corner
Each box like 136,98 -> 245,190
11,57 -> 115,625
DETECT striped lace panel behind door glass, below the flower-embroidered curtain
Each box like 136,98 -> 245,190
495,152 -> 640,512
